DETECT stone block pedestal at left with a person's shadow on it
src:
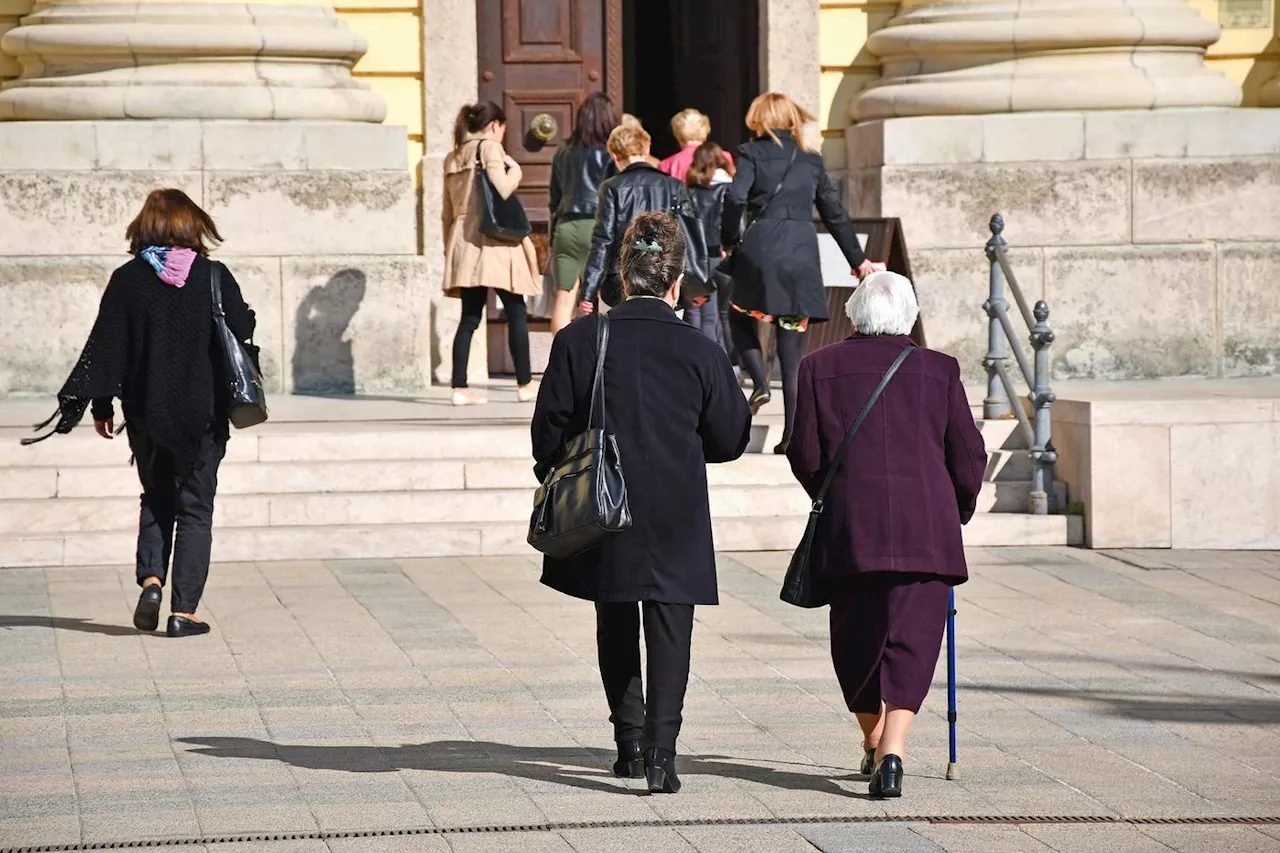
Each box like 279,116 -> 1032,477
0,120 -> 438,397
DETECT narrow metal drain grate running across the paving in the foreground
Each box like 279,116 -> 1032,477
0,815 -> 1280,853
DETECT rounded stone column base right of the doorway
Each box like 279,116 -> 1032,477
852,0 -> 1240,120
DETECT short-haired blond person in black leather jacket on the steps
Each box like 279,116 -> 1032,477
579,124 -> 707,314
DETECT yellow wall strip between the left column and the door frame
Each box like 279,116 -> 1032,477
338,0 -> 422,185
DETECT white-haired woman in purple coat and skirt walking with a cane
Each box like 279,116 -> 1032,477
787,272 -> 987,797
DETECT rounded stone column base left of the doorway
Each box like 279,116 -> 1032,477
0,0 -> 387,122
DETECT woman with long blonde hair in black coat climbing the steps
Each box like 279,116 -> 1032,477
722,92 -> 884,453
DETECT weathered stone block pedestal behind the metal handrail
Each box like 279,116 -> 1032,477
846,109 -> 1280,380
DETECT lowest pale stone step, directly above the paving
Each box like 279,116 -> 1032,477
0,515 -> 1082,563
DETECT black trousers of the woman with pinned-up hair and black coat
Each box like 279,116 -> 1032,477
595,601 -> 694,752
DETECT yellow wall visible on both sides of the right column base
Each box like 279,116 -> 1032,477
819,0 -> 1280,169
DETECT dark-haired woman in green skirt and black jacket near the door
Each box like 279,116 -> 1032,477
550,92 -> 621,334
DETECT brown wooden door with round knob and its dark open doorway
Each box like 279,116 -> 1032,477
476,0 -> 759,224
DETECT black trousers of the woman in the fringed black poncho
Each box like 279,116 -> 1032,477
125,423 -> 227,613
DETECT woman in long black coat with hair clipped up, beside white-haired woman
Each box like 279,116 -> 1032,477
532,213 -> 751,793
